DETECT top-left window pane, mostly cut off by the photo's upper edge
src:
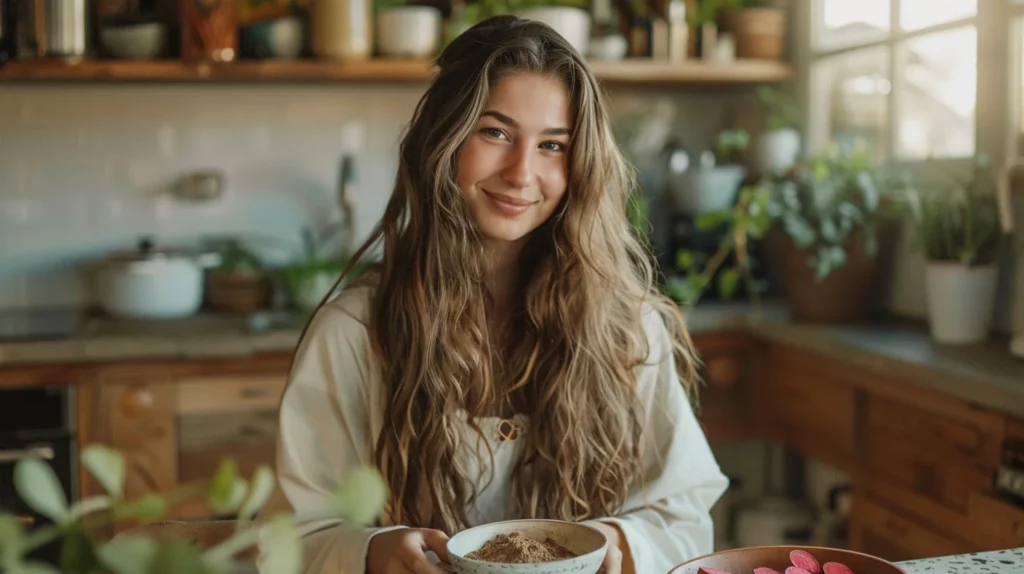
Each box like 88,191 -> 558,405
814,0 -> 889,50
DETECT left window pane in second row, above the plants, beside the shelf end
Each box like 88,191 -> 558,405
809,46 -> 891,160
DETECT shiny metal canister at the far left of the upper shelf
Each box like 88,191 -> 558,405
12,0 -> 89,59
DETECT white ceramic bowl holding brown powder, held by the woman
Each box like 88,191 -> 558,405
447,520 -> 607,574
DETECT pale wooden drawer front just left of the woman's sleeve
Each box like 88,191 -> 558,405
177,374 -> 288,415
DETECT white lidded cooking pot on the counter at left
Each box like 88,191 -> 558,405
96,238 -> 217,319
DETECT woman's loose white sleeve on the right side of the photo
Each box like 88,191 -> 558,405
600,310 -> 728,574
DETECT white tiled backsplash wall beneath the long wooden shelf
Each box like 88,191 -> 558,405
0,84 -> 750,309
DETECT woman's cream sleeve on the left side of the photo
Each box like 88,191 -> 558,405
267,294 -> 396,574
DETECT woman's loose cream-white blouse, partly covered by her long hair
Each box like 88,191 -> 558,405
268,286 -> 728,574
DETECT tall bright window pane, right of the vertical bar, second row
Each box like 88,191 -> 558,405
896,26 -> 978,159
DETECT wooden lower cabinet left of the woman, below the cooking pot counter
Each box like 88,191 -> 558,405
81,362 -> 287,526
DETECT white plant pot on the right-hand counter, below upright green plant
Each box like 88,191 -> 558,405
925,263 -> 998,345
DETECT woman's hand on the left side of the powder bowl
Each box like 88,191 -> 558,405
367,528 -> 450,574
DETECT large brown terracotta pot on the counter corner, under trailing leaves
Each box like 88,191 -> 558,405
782,232 -> 885,323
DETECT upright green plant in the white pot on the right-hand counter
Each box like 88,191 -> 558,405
907,156 -> 1007,267
